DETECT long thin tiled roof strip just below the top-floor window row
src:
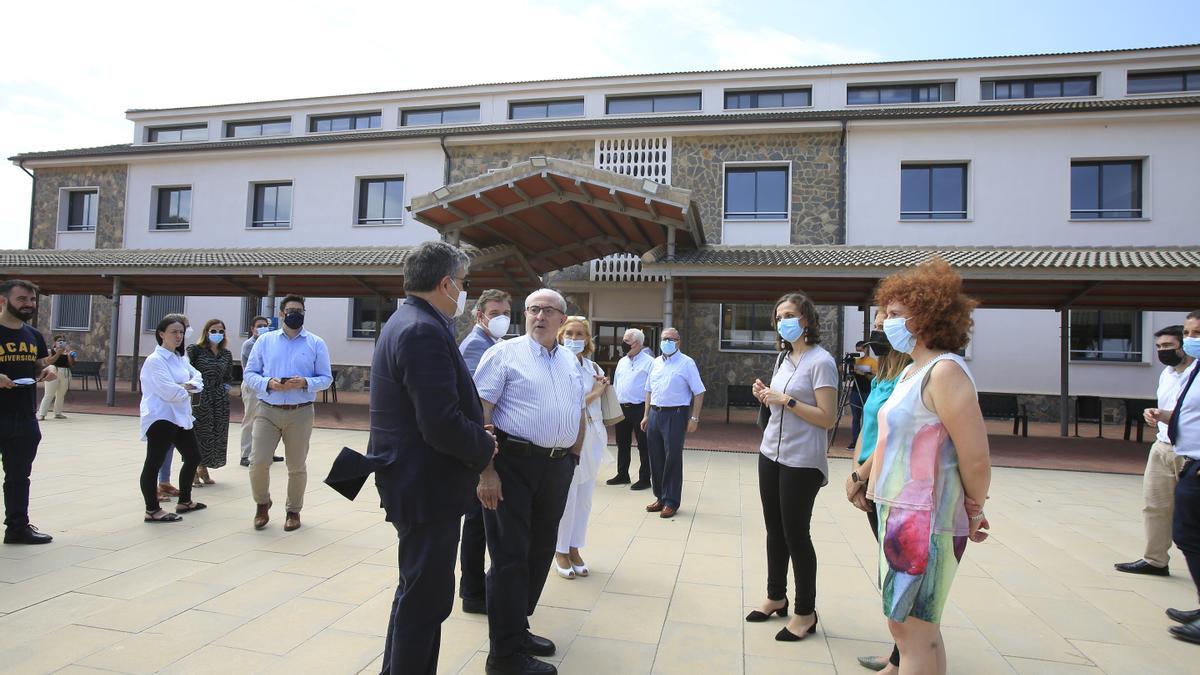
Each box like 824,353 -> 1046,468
8,96 -> 1200,162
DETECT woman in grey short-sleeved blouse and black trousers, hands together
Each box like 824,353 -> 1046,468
746,292 -> 838,643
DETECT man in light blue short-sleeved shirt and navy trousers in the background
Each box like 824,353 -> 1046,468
642,328 -> 704,518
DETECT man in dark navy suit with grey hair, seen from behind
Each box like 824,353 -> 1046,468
367,241 -> 497,674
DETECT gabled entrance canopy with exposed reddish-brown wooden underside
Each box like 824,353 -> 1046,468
409,157 -> 704,279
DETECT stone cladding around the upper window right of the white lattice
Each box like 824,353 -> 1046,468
671,132 -> 845,244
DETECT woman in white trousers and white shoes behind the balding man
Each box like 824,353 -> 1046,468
554,316 -> 608,579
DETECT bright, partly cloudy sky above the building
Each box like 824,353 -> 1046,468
0,0 -> 1200,249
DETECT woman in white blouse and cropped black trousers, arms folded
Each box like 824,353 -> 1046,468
140,316 -> 205,522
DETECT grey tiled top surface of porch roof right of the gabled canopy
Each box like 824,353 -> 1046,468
642,245 -> 1200,271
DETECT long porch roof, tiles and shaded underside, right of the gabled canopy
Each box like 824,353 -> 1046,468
642,245 -> 1200,311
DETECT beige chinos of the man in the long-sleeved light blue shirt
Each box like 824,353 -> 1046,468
250,401 -> 314,513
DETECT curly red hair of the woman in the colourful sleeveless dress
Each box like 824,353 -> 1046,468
875,256 -> 979,352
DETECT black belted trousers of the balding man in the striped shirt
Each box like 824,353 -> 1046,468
484,450 -> 575,657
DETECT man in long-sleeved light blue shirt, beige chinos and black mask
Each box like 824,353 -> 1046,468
244,295 -> 334,532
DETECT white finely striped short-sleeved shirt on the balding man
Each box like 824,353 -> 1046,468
475,335 -> 583,448
